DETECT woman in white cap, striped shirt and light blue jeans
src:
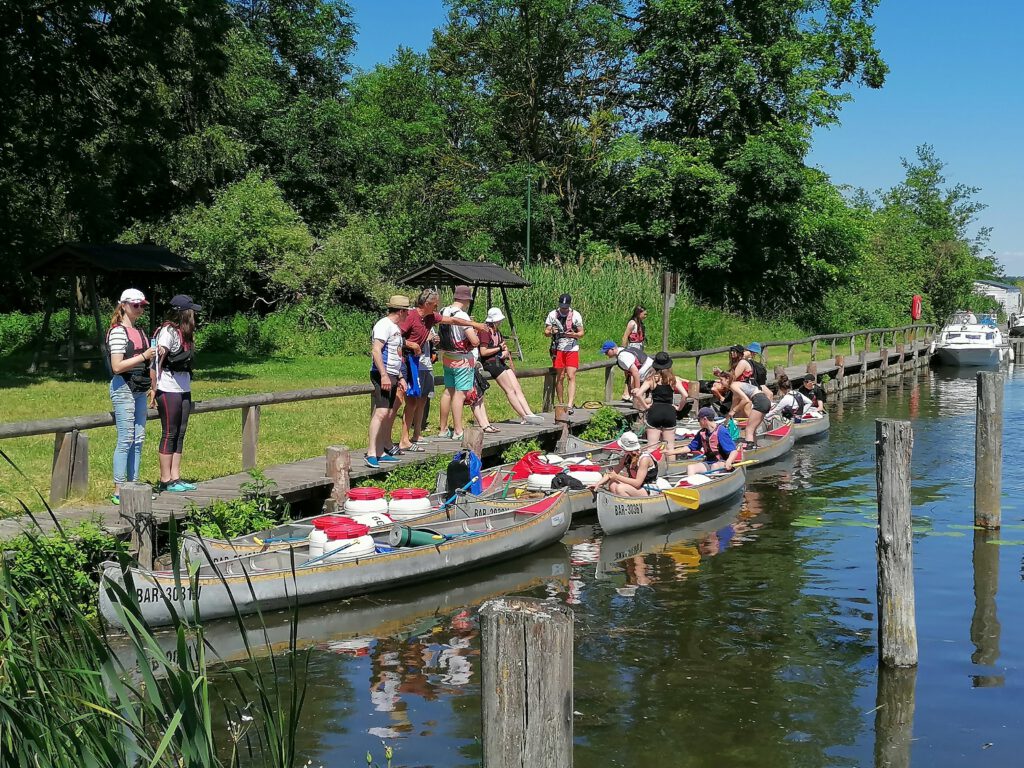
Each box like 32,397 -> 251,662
106,288 -> 157,504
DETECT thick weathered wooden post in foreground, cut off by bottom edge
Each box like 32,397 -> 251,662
480,597 -> 573,768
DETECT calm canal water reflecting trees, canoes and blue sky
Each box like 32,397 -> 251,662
203,369 -> 1024,768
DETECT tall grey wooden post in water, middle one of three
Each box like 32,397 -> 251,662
874,419 -> 918,667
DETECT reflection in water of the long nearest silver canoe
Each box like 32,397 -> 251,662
119,544 -> 569,664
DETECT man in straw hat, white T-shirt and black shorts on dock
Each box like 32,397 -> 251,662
367,295 -> 409,469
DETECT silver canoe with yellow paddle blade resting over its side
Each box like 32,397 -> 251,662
597,468 -> 746,534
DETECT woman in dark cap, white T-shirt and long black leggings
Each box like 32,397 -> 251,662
154,294 -> 203,494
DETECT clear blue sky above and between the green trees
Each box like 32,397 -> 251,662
350,0 -> 1024,274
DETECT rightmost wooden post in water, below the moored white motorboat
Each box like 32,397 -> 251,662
974,371 -> 1002,528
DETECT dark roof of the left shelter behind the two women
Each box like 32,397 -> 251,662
29,243 -> 193,274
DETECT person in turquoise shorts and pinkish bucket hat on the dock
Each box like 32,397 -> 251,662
438,286 -> 480,440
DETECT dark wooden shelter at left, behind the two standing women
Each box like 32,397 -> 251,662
29,243 -> 193,373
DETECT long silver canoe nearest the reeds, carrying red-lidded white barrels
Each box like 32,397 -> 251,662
99,494 -> 571,626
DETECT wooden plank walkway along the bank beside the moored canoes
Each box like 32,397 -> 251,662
0,347 -> 929,540
